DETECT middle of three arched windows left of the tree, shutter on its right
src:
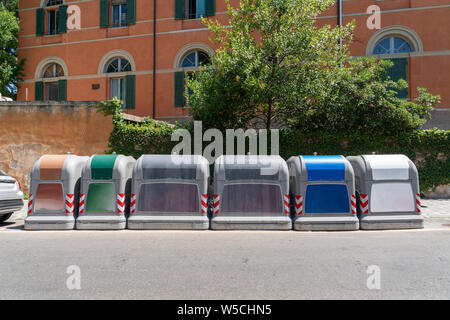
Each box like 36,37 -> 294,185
104,58 -> 135,109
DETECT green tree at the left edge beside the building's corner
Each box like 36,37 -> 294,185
0,0 -> 25,98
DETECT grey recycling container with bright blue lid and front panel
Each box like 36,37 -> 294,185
287,155 -> 359,231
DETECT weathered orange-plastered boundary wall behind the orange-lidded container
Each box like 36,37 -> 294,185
0,102 -> 113,193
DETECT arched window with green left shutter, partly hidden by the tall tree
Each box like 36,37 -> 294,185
175,50 -> 210,107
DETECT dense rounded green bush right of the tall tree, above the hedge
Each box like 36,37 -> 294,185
285,57 -> 440,136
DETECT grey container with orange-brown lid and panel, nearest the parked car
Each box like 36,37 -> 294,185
25,154 -> 89,230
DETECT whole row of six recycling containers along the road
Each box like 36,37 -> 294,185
25,154 -> 423,230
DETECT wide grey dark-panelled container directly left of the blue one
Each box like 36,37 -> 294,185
211,155 -> 292,230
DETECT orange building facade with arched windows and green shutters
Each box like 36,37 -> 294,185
18,0 -> 450,120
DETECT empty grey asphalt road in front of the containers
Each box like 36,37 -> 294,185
0,226 -> 450,299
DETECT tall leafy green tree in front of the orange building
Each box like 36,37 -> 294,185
187,0 -> 353,128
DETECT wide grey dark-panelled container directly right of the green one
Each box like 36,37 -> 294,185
128,155 -> 209,230
